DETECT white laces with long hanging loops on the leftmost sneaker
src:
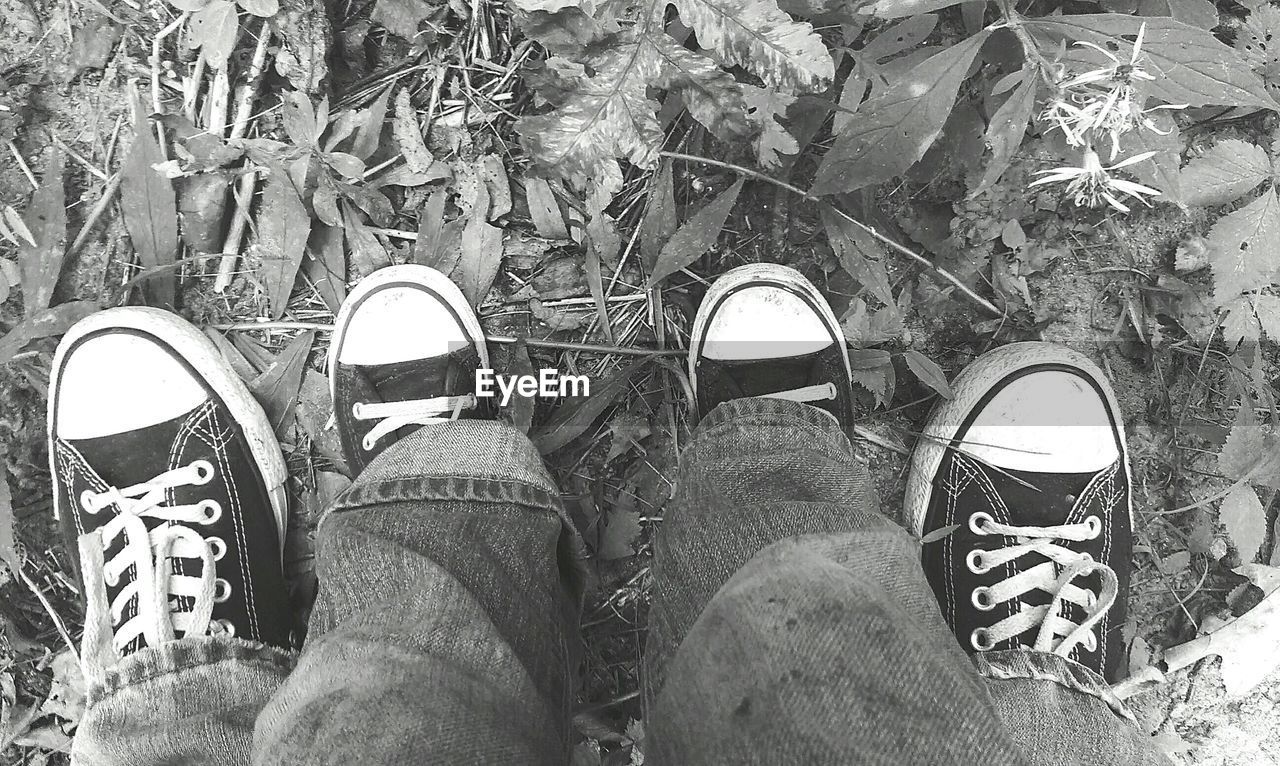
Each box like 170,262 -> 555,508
79,460 -> 234,675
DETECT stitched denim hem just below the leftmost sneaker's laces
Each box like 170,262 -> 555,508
86,635 -> 298,707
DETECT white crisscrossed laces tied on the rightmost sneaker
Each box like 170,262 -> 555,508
965,512 -> 1119,657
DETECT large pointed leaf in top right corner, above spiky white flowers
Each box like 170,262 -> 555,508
1024,13 -> 1280,109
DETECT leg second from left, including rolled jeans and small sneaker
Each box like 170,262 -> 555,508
253,266 -> 579,765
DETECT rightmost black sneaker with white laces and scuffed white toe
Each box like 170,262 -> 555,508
905,343 -> 1133,679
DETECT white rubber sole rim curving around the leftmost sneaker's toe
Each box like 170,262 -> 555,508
46,306 -> 289,556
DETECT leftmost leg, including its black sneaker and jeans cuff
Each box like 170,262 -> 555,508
49,307 -> 293,766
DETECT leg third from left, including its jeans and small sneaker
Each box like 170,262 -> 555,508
645,266 -> 1019,765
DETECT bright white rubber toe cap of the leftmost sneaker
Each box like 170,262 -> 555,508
56,332 -> 209,439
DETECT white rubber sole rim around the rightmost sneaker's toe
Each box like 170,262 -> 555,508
902,341 -> 1133,537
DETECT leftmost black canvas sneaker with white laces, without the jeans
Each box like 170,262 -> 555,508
49,307 -> 292,667
